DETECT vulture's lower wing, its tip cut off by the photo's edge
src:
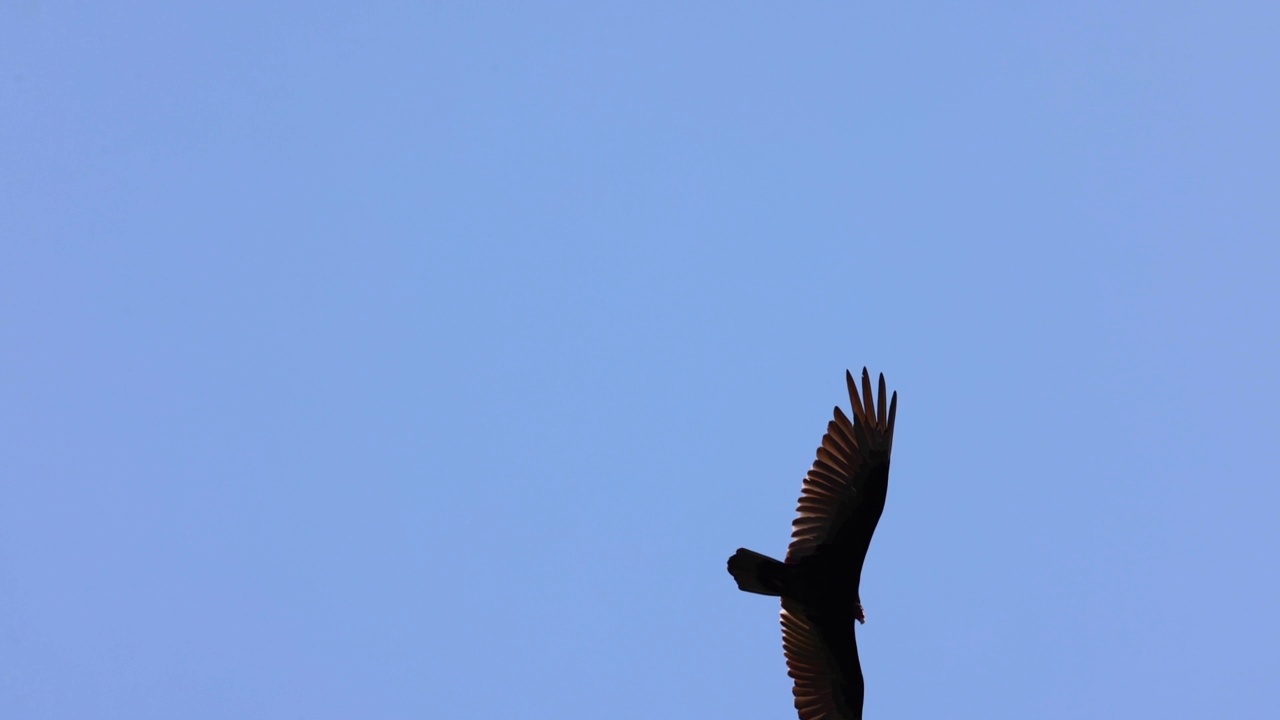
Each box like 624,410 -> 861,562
782,598 -> 863,720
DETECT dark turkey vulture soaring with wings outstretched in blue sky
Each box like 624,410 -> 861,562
728,368 -> 897,720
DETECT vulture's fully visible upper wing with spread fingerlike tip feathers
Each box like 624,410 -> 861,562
786,368 -> 897,563
